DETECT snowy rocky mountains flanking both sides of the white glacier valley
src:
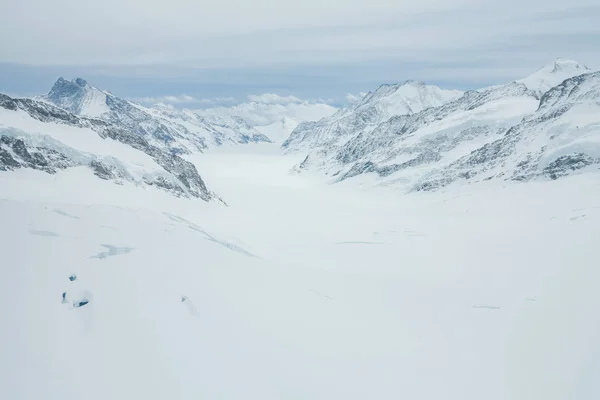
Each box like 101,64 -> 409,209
0,59 -> 600,201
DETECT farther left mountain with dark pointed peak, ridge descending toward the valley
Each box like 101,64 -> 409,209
41,78 -> 270,154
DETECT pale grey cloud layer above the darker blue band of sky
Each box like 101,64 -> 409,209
0,0 -> 600,72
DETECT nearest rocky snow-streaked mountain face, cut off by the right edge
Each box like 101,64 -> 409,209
415,72 -> 600,190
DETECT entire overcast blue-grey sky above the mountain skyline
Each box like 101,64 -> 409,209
0,0 -> 600,103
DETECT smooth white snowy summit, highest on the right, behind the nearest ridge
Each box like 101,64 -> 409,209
517,58 -> 592,97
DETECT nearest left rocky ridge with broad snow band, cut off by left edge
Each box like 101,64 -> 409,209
0,94 -> 219,201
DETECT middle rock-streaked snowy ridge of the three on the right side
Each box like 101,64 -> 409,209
322,83 -> 538,188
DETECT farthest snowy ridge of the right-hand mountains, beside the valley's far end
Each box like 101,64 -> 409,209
282,81 -> 462,152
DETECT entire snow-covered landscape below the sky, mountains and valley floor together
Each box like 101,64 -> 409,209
0,59 -> 600,400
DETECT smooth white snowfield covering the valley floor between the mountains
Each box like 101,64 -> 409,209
0,144 -> 600,400
